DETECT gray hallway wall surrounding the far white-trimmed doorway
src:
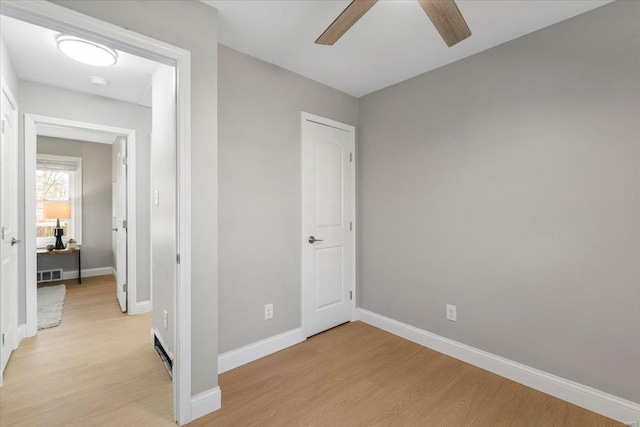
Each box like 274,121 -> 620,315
18,80 -> 151,310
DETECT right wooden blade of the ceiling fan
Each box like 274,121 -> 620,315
418,0 -> 471,47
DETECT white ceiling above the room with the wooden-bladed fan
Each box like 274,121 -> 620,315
208,0 -> 612,97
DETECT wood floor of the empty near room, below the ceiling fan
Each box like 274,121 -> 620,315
190,322 -> 618,427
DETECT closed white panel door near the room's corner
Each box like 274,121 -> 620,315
302,115 -> 355,336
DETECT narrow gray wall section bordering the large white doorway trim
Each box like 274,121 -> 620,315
55,0 -> 218,394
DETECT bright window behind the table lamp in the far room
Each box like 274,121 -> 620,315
36,154 -> 82,248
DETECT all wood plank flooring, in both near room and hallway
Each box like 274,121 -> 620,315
0,278 -> 621,427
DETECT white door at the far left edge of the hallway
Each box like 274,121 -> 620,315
0,85 -> 19,374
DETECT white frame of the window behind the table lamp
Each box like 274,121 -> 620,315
36,154 -> 82,248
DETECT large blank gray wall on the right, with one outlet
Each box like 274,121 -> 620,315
358,1 -> 640,402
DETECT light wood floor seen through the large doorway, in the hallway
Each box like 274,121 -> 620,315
0,276 -> 175,427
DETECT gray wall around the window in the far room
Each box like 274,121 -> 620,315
37,136 -> 114,271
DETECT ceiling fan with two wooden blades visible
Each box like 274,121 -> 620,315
316,0 -> 471,47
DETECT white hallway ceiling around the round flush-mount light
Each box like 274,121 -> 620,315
0,16 -> 158,107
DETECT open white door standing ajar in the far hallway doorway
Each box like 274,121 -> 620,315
113,137 -> 127,312
